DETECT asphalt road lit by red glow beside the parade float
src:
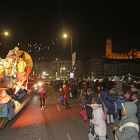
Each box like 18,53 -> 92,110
0,87 -> 114,140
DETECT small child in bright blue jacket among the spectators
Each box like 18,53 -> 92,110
114,91 -> 125,120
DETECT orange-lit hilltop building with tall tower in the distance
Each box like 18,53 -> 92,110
106,39 -> 140,59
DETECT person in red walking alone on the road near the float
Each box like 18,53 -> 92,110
38,85 -> 46,110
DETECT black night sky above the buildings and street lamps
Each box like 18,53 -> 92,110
0,0 -> 140,59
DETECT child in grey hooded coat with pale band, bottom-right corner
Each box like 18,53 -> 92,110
113,102 -> 139,140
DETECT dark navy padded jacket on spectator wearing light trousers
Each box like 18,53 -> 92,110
106,94 -> 116,115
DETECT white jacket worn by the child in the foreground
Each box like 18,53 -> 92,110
90,104 -> 106,136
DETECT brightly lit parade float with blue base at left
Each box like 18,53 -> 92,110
0,47 -> 33,129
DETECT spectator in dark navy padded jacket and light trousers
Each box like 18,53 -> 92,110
106,90 -> 116,125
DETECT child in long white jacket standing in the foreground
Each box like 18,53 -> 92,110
87,96 -> 106,140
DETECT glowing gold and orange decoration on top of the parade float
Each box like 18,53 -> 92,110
0,47 -> 33,104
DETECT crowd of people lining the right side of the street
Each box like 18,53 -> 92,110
51,78 -> 140,140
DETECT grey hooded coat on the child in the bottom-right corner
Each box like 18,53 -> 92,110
116,102 -> 138,140
